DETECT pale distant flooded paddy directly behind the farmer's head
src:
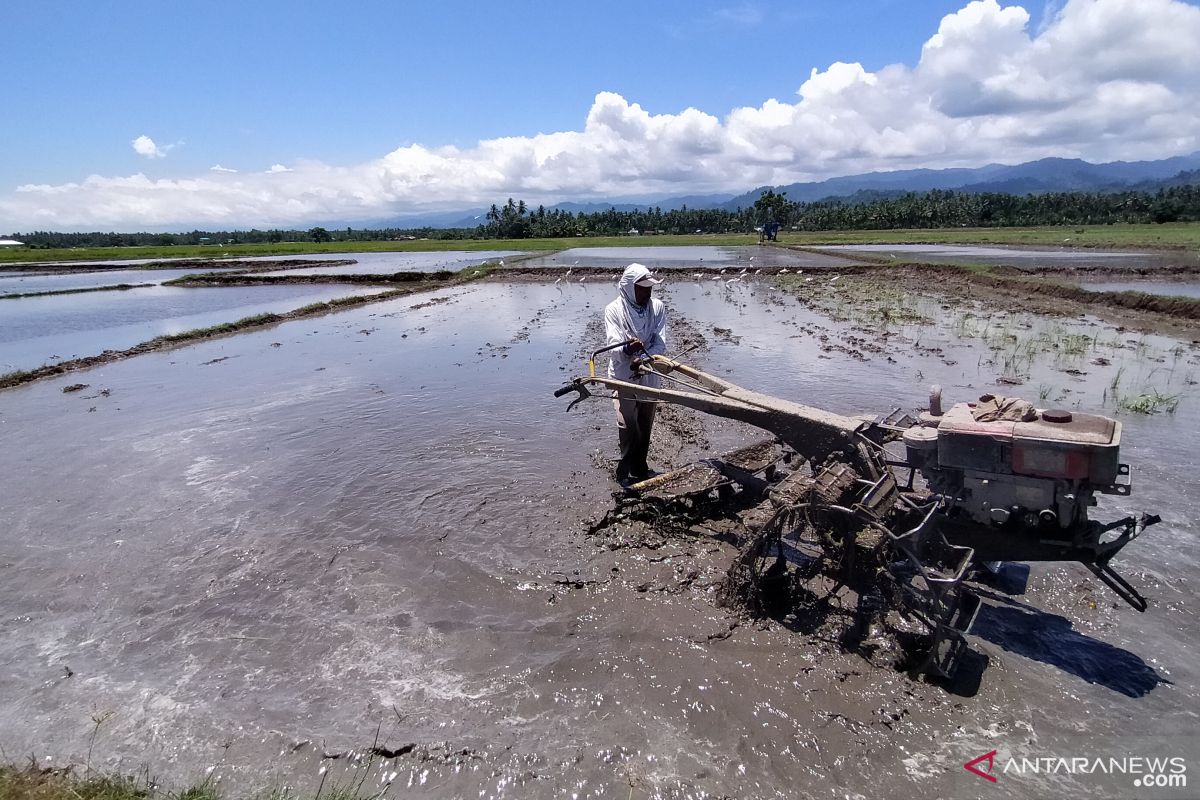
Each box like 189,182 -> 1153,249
521,246 -> 853,272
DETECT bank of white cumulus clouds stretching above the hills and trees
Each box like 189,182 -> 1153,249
14,0 -> 1200,229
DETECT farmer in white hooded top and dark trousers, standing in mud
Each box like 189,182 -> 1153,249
604,264 -> 667,483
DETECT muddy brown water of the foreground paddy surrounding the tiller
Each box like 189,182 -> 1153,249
0,281 -> 1200,798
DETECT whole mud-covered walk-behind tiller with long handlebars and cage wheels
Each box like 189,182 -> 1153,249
554,348 -> 1159,676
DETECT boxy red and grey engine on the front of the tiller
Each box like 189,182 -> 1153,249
904,398 -> 1129,531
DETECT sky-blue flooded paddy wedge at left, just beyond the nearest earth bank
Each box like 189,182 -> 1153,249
0,285 -> 384,372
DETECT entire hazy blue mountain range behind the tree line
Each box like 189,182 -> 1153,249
377,152 -> 1200,228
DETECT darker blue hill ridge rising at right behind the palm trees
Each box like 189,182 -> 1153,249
721,152 -> 1200,211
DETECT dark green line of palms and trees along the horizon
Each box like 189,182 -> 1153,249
12,181 -> 1200,247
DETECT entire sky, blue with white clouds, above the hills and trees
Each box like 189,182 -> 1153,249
0,0 -> 1200,230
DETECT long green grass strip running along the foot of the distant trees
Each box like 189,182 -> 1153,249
0,222 -> 1200,264
